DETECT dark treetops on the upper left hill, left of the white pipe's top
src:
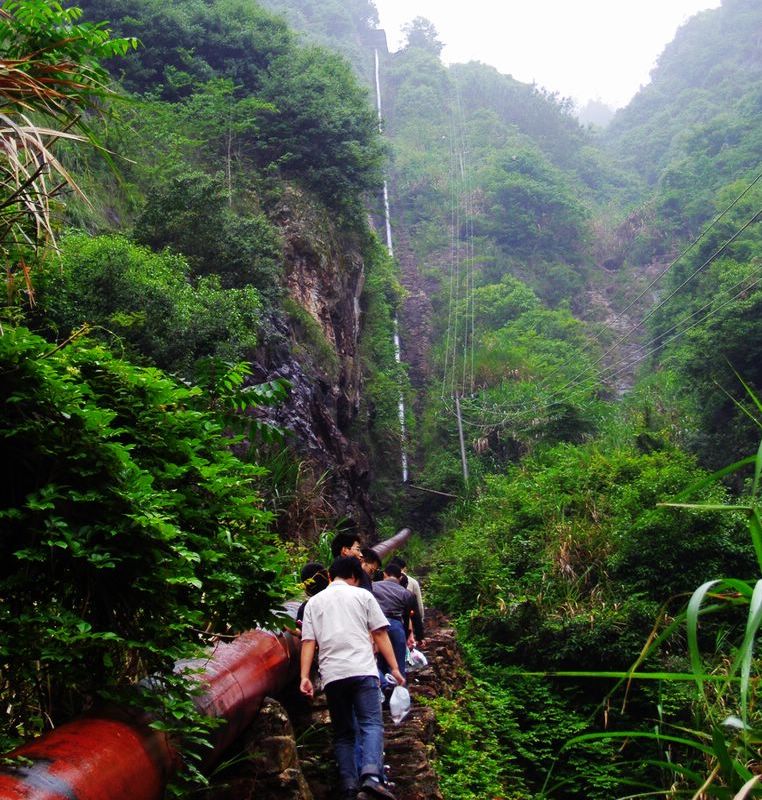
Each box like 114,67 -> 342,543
75,0 -> 381,216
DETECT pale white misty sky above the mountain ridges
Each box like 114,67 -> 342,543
375,0 -> 720,108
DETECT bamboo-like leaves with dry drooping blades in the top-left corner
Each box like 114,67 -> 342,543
0,0 -> 136,299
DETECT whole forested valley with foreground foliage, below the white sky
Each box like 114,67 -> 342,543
0,0 -> 762,800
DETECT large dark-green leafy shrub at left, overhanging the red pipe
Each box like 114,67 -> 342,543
0,328 -> 281,746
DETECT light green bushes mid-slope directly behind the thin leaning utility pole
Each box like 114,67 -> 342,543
421,296 -> 605,493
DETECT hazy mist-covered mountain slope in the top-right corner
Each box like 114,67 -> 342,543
603,0 -> 762,228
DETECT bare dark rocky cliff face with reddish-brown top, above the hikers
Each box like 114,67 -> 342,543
254,189 -> 373,533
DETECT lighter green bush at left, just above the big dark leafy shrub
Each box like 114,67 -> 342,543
36,234 -> 262,377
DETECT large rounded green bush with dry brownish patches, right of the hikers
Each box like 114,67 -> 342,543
430,445 -> 752,669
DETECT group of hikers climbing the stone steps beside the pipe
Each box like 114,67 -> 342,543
297,532 -> 423,800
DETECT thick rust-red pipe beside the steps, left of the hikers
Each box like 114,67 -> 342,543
0,630 -> 298,800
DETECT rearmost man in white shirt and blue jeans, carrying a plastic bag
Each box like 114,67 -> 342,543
299,556 -> 405,800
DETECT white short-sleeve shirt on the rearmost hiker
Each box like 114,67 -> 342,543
302,578 -> 389,685
